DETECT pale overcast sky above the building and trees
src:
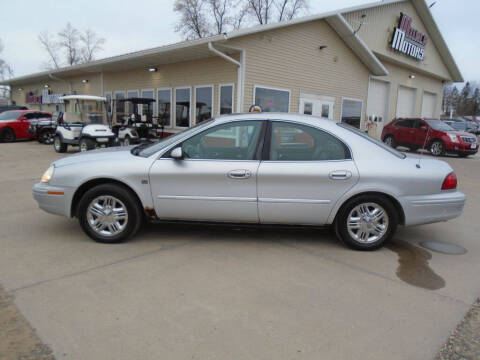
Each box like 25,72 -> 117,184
0,0 -> 480,81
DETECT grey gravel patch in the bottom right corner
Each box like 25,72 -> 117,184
435,298 -> 480,360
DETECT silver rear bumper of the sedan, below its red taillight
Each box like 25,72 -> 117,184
400,190 -> 466,226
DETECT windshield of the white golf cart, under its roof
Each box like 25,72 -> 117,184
63,99 -> 108,125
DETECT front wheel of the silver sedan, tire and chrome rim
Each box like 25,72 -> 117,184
77,184 -> 143,244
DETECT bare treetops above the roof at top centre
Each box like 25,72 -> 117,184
174,0 -> 308,40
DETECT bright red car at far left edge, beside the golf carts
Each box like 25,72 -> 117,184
0,110 -> 52,142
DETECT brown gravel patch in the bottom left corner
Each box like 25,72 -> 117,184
0,286 -> 55,360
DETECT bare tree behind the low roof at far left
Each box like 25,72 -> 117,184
38,23 -> 105,69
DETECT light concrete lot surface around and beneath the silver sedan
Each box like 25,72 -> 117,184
0,142 -> 480,360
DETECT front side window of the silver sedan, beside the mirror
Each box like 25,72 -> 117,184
182,121 -> 262,160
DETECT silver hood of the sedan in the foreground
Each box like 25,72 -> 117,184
53,146 -> 135,167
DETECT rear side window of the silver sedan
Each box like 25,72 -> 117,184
269,121 -> 351,161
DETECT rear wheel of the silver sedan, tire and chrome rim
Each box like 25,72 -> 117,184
334,194 -> 398,251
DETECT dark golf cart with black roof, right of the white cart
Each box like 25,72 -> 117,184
113,98 -> 158,146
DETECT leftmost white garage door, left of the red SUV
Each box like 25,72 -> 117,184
367,79 -> 391,136
